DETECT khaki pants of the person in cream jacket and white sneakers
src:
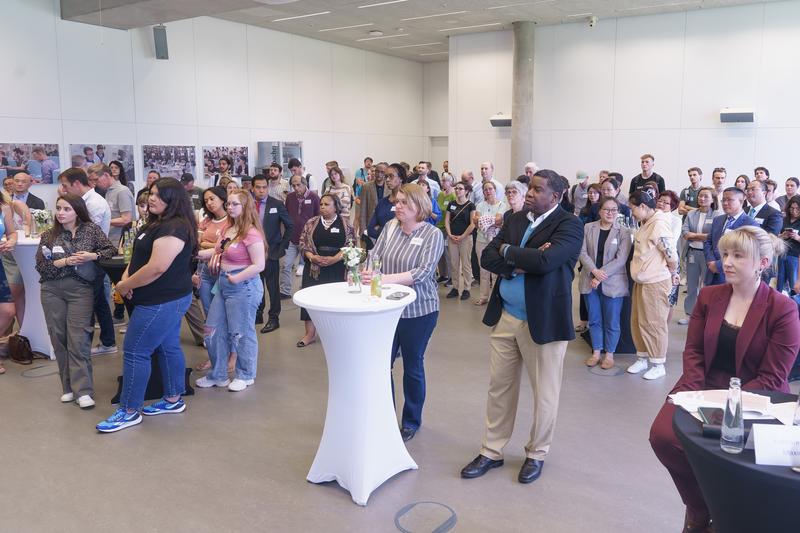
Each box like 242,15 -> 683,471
631,279 -> 672,364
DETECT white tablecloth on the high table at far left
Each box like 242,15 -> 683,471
14,237 -> 55,359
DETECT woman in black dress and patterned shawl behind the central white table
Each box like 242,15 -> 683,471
297,193 -> 355,348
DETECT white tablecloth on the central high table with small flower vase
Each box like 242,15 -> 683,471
294,283 -> 417,505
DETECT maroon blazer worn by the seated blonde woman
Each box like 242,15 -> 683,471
672,282 -> 800,392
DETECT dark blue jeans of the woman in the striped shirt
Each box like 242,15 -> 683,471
392,311 -> 439,429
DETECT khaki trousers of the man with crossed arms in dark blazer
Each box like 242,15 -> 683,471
481,311 -> 567,460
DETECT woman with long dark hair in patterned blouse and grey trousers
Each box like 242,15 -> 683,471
36,193 -> 116,409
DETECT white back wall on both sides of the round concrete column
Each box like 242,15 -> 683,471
450,1 -> 800,189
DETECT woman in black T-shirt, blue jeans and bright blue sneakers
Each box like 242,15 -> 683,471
97,178 -> 197,433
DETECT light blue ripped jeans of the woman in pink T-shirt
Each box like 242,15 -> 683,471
206,270 -> 264,381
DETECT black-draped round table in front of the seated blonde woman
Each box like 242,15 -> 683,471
672,392 -> 800,533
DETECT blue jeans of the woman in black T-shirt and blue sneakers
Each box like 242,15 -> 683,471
119,293 -> 192,411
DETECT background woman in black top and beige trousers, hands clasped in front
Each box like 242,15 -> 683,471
444,181 -> 475,300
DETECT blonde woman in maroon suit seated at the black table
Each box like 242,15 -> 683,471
650,226 -> 800,532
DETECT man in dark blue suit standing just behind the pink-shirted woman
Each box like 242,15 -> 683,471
253,174 -> 292,333
